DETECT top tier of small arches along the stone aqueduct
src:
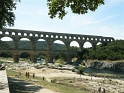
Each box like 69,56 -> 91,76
0,29 -> 113,41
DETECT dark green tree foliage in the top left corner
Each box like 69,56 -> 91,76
0,0 -> 20,29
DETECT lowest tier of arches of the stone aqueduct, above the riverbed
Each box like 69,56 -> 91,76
0,50 -> 71,63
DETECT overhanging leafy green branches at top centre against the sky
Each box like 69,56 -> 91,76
47,0 -> 104,19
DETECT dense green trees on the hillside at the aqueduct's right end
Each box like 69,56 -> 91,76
80,40 -> 124,60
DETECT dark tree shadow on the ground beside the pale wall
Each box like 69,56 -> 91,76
8,77 -> 42,93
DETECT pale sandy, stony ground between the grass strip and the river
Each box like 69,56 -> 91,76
23,68 -> 124,93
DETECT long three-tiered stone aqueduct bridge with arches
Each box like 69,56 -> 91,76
0,29 -> 114,62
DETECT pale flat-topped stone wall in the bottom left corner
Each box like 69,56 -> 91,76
0,70 -> 10,93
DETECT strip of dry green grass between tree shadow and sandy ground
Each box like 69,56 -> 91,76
7,70 -> 89,93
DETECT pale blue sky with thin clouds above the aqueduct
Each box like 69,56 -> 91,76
6,0 -> 124,46
